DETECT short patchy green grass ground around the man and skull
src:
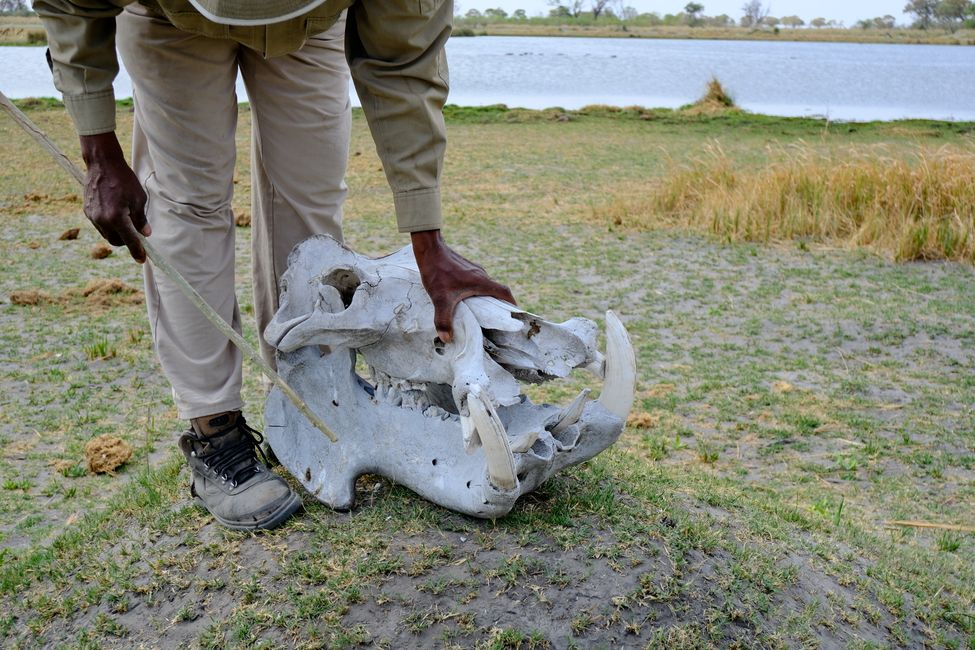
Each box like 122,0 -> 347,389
0,102 -> 975,648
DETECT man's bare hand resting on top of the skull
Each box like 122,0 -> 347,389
411,230 -> 515,343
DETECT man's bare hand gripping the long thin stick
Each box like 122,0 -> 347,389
81,133 -> 152,264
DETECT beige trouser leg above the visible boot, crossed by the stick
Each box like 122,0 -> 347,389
118,9 -> 243,419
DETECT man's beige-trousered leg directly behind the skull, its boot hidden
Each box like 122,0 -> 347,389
240,19 -> 351,364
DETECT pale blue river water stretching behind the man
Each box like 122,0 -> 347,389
0,36 -> 975,121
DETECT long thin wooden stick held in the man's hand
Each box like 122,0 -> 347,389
0,92 -> 338,442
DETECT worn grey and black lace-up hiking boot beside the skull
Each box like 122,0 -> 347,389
179,411 -> 301,530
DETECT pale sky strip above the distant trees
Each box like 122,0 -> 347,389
462,0 -> 909,26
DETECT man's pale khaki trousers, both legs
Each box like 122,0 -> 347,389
118,5 -> 351,419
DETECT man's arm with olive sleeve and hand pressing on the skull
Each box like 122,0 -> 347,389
345,0 -> 514,341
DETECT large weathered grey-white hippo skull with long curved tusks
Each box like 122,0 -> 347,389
264,235 -> 636,518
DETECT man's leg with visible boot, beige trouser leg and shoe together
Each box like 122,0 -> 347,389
118,5 -> 301,530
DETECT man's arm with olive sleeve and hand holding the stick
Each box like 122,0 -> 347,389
34,0 -> 151,262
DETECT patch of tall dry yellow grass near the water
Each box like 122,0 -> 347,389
604,144 -> 975,263
